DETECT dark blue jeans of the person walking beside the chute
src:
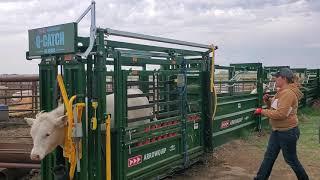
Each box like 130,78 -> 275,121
254,127 -> 309,180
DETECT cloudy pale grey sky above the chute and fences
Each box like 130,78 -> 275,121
0,0 -> 320,74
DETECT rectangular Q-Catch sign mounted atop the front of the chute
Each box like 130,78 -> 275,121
29,23 -> 77,56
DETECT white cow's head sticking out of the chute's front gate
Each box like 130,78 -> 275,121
25,105 -> 67,160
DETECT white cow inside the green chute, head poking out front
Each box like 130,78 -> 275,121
26,89 -> 152,160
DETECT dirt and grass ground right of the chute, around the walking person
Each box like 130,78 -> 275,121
167,109 -> 320,180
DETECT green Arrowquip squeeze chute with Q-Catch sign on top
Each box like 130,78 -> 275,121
27,2 -> 216,180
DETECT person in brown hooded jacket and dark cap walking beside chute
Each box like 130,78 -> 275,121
254,68 -> 309,180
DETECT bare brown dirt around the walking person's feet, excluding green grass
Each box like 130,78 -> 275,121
168,140 -> 320,180
